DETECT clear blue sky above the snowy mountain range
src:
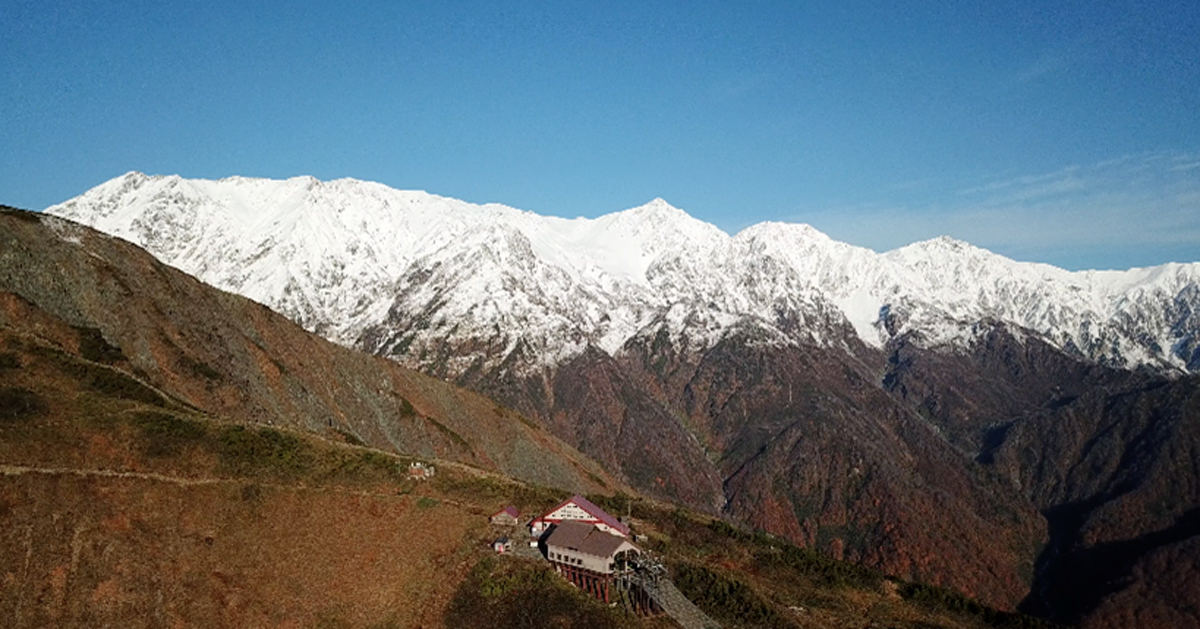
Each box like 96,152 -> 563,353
0,0 -> 1200,268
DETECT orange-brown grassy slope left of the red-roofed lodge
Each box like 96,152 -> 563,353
0,330 -> 604,627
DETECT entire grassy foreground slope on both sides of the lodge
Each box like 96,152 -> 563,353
0,330 -> 1051,627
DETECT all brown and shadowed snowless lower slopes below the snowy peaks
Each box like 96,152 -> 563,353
422,323 -> 1200,625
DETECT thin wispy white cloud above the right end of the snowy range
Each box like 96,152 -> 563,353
797,152 -> 1200,268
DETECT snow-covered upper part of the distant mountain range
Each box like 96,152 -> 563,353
46,173 -> 1200,376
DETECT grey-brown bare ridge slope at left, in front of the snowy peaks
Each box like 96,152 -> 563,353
0,210 -> 617,491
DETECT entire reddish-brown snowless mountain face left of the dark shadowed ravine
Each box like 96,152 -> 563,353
439,328 -> 1045,607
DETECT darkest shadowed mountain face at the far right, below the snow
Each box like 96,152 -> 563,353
886,329 -> 1200,627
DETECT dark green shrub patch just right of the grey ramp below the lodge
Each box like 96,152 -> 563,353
671,563 -> 792,627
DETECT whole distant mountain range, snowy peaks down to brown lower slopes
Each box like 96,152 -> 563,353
47,173 -> 1200,627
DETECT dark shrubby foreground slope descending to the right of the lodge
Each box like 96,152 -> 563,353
594,496 -> 1045,628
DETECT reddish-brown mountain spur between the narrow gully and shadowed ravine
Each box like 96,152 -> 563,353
685,339 -> 1043,605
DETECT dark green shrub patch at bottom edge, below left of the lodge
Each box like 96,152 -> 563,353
444,556 -> 637,629
